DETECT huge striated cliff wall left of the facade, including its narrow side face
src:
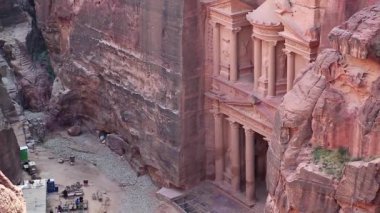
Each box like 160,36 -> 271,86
35,0 -> 204,186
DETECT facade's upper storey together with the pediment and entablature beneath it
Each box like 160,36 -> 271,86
206,0 -> 348,136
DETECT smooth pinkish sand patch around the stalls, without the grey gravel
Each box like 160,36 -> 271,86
34,147 -> 125,213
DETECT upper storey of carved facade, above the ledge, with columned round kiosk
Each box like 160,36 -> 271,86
209,0 -> 326,98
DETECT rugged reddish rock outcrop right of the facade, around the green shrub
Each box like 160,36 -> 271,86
266,4 -> 380,213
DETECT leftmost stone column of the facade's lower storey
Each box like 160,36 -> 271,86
214,113 -> 224,182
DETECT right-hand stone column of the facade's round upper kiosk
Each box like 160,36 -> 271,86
268,42 -> 276,96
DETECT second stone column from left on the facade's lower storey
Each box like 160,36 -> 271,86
230,120 -> 240,192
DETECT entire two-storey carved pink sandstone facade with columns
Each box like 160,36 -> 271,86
206,0 -> 380,206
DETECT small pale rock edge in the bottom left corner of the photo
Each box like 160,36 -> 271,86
0,171 -> 26,213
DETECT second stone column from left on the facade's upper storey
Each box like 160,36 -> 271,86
230,28 -> 240,82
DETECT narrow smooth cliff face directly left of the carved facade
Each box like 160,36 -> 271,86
180,0 -> 205,184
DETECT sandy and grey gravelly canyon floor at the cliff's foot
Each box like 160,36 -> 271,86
26,131 -> 176,213
